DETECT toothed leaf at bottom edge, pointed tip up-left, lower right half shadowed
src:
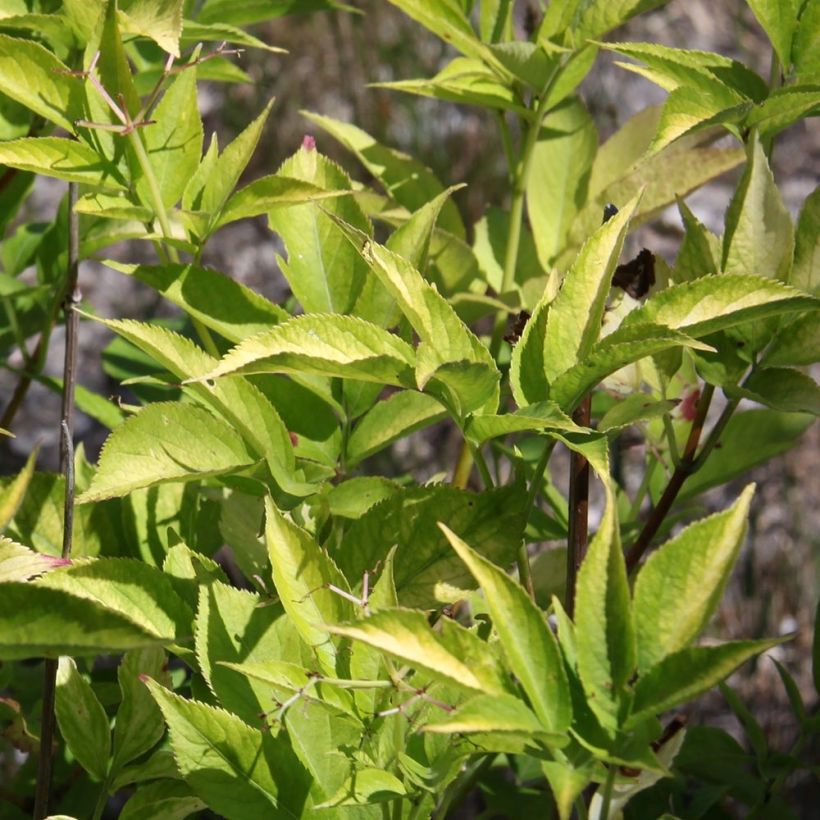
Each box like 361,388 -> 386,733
148,681 -> 309,820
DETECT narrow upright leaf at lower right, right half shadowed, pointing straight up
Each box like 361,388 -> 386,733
575,493 -> 635,736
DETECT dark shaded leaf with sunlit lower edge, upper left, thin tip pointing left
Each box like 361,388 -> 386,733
109,263 -> 290,342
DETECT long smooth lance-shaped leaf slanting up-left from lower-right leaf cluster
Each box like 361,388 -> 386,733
440,525 -> 572,734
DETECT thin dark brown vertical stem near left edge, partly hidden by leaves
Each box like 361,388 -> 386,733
34,182 -> 80,820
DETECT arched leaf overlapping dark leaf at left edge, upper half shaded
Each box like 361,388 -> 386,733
31,558 -> 193,642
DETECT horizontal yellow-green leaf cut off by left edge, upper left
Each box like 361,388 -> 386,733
0,137 -> 125,190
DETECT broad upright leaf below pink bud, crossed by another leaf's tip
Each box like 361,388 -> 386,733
268,145 -> 373,313
